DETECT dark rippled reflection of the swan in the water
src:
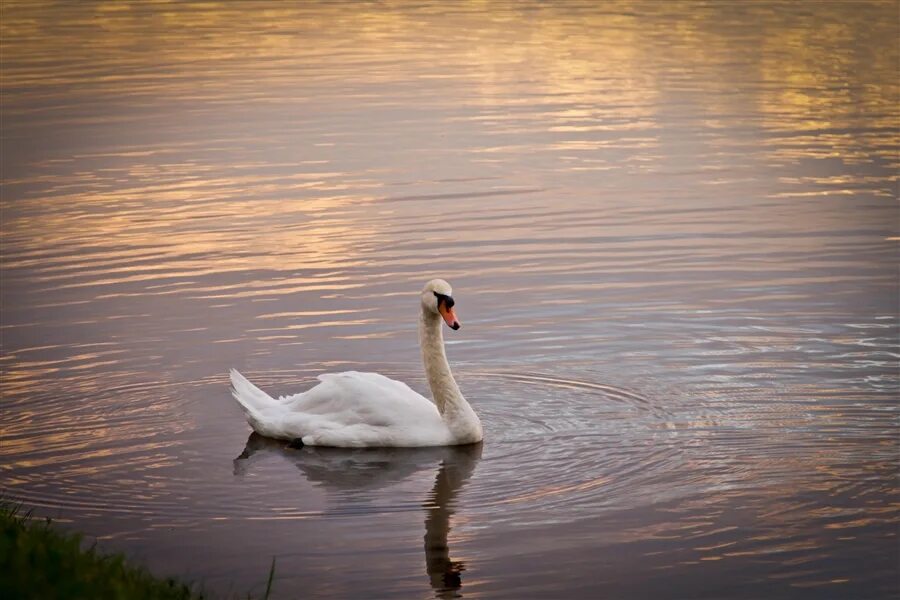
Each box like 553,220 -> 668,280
234,433 -> 482,598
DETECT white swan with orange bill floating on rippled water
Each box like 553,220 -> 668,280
231,279 -> 483,448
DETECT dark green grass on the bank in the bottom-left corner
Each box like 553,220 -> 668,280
0,503 -> 207,600
